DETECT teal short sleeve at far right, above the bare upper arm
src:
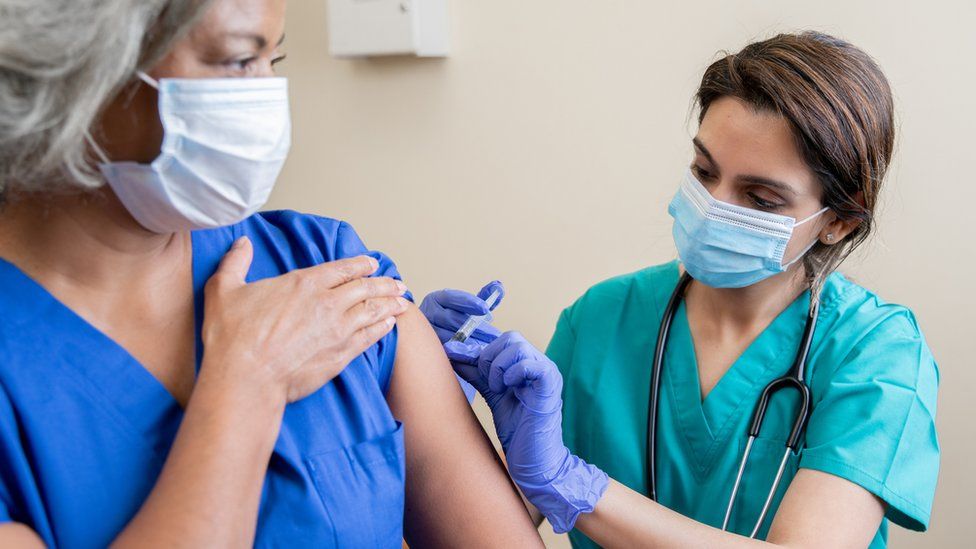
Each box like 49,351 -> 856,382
800,310 -> 939,531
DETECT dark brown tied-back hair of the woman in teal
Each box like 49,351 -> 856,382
695,32 -> 895,299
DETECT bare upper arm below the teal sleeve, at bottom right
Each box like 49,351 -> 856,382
766,469 -> 885,549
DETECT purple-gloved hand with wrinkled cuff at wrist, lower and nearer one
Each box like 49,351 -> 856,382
446,332 -> 609,533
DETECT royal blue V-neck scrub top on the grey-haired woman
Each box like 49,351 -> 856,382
0,211 -> 412,547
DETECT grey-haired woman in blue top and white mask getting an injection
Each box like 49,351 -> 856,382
0,0 -> 541,547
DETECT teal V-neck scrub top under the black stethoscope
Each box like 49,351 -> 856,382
547,262 -> 939,549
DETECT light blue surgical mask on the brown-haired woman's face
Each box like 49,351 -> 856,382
668,170 -> 828,288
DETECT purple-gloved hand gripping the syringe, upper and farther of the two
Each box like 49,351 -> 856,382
420,280 -> 505,402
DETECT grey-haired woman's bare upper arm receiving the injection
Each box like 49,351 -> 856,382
387,307 -> 543,547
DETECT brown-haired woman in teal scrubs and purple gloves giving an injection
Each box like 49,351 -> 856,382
422,33 -> 939,549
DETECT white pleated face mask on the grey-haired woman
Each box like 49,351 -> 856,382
92,72 -> 291,233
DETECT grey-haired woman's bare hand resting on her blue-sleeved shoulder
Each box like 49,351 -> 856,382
201,238 -> 408,402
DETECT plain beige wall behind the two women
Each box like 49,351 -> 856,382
271,0 -> 976,547
